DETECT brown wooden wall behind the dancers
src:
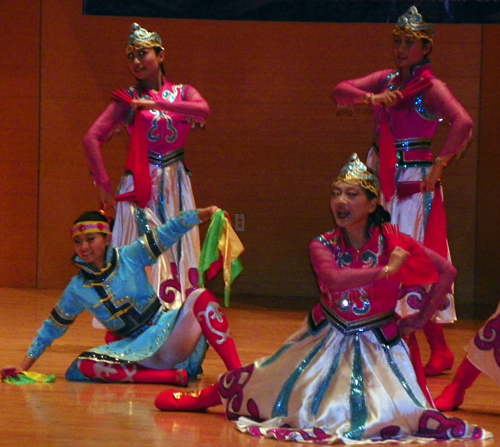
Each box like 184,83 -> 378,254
0,0 -> 500,318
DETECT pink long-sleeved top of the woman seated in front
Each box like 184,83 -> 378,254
309,228 -> 456,338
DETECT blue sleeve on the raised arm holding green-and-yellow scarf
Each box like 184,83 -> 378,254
119,210 -> 200,267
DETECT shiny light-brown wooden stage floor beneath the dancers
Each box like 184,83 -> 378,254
0,289 -> 500,447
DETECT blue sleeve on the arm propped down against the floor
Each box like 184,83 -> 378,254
27,280 -> 85,359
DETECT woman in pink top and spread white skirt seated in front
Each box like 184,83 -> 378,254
155,154 -> 492,444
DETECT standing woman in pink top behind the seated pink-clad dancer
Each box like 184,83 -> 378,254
332,6 -> 473,376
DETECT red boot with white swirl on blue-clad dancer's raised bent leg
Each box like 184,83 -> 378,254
193,290 -> 241,371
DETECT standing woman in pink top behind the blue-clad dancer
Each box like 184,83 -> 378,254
83,23 -> 209,309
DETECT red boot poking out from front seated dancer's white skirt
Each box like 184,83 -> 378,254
155,384 -> 222,411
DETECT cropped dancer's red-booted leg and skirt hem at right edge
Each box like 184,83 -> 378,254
434,303 -> 500,411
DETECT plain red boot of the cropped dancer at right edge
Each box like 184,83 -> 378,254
434,357 -> 481,411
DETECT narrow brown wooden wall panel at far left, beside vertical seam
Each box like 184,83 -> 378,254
0,0 -> 40,287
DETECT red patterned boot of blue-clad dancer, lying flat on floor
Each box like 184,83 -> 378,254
78,360 -> 189,386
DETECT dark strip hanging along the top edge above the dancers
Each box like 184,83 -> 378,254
83,0 -> 500,24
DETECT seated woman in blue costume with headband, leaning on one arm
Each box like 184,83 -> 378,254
2,206 -> 241,386
